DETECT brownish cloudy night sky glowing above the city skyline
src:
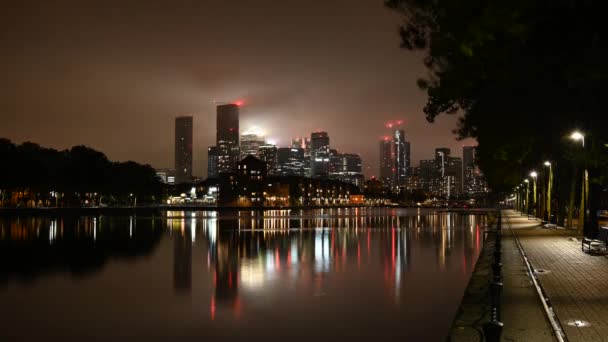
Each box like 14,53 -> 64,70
0,0 -> 470,176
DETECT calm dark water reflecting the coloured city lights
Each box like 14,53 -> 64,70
0,208 -> 486,341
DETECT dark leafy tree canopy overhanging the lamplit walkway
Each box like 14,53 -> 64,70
386,0 -> 608,234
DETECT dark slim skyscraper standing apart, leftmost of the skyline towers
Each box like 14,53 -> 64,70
175,116 -> 192,183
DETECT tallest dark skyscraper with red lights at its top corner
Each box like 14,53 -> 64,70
216,104 -> 240,173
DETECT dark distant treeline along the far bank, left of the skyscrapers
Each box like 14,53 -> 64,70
0,138 -> 163,206
